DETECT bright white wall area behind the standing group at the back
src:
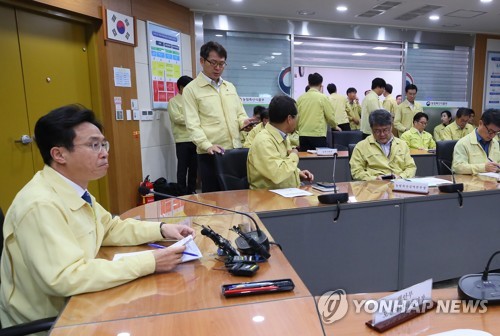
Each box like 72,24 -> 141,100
293,67 -> 404,103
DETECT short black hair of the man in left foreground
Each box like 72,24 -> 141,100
35,105 -> 103,165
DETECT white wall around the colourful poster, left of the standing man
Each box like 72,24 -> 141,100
135,20 -> 193,182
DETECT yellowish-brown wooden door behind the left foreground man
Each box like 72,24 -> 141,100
0,7 -> 99,209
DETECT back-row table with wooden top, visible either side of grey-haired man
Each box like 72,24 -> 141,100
299,149 -> 438,182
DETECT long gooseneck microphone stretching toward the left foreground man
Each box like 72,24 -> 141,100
139,186 -> 269,254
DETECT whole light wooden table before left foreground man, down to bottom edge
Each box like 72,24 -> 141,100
51,211 -> 324,336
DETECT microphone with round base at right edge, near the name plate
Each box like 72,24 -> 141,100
458,251 -> 500,303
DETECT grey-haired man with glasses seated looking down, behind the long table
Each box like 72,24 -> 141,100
349,110 -> 417,181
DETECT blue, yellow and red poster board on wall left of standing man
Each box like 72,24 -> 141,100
147,21 -> 182,109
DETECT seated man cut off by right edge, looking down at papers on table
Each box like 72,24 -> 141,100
453,109 -> 500,174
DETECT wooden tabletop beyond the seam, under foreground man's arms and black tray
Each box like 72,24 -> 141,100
52,213 -> 319,328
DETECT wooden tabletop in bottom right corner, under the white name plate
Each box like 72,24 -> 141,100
316,288 -> 500,336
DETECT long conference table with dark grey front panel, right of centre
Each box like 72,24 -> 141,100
180,175 -> 500,295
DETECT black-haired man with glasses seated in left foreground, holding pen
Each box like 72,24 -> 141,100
0,105 -> 194,327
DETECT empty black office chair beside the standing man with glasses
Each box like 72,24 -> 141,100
215,148 -> 249,191
